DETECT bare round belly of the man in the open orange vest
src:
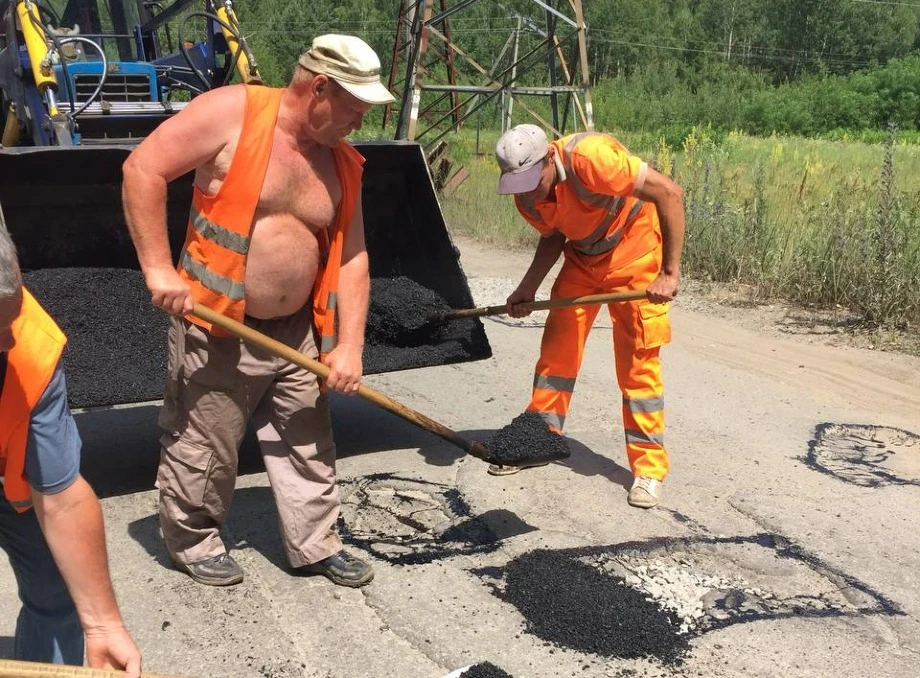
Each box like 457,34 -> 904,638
246,215 -> 319,319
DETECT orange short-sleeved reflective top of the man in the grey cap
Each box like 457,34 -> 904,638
515,132 -> 659,261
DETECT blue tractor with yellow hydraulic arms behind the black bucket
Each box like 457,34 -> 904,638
0,0 -> 261,148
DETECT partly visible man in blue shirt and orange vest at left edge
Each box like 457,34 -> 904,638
0,212 -> 141,678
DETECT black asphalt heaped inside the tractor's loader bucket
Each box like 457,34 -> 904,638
23,268 -> 488,408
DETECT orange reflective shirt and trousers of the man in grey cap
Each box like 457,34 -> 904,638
516,132 -> 671,480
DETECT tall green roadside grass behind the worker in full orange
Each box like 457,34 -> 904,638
434,129 -> 920,333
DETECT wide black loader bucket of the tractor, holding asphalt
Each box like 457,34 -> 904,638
0,142 -> 491,408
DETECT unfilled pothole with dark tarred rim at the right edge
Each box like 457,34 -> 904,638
806,423 -> 920,487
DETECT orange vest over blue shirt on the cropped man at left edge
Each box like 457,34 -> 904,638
0,288 -> 67,513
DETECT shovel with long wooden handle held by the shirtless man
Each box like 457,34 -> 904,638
187,304 -> 557,470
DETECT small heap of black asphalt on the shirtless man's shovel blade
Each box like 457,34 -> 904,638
484,412 -> 571,466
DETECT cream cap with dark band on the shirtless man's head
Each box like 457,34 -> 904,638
297,33 -> 396,104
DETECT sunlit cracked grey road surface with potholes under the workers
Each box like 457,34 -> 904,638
0,239 -> 920,678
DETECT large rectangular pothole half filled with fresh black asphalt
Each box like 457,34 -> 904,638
477,534 -> 903,664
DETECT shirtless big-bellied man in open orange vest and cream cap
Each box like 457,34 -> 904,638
123,35 -> 393,586
